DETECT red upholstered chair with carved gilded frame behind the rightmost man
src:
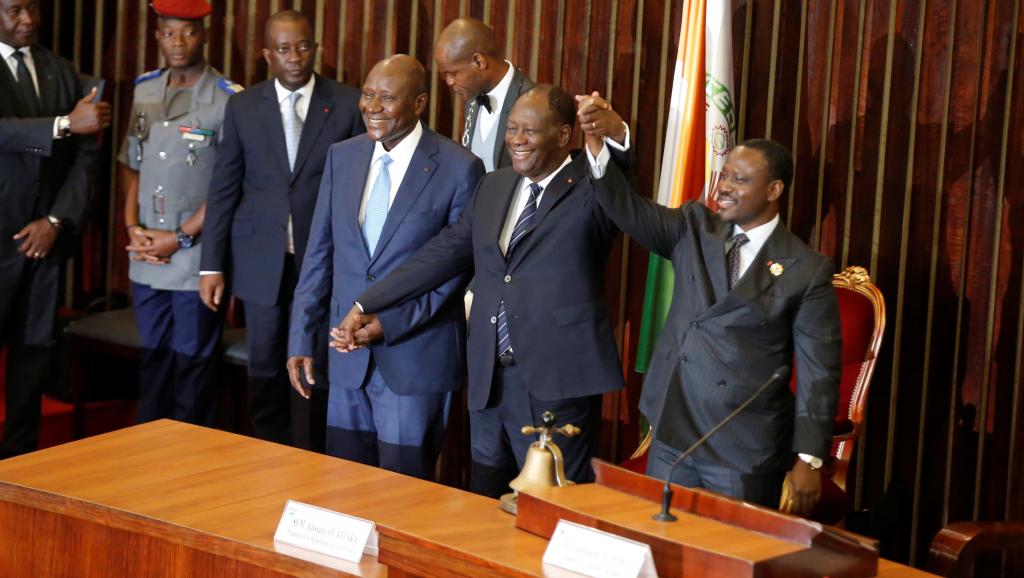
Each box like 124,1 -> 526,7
623,266 -> 886,524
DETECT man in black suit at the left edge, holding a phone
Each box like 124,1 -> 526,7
0,0 -> 111,458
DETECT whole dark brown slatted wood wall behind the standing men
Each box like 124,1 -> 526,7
36,0 -> 1024,564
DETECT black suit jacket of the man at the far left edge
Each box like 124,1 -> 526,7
0,46 -> 97,344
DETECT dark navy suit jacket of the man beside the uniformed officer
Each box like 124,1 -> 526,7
200,75 -> 366,306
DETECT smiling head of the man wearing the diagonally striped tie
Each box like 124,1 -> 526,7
505,91 -> 572,182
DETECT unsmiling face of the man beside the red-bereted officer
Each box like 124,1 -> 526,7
263,18 -> 316,90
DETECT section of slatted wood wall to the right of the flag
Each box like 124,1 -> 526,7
732,0 -> 1024,575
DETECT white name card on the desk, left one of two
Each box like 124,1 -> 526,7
273,500 -> 377,564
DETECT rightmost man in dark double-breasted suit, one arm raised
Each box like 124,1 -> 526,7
585,122 -> 841,514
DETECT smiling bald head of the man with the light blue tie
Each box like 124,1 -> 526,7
359,56 -> 427,151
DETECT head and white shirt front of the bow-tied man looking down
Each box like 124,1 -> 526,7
434,17 -> 534,172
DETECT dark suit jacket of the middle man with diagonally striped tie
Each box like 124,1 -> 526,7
357,154 -> 623,410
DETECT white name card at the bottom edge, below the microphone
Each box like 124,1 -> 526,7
544,520 -> 657,578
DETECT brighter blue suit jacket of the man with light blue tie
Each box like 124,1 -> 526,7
289,125 -> 483,395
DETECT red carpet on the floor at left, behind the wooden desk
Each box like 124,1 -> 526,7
0,352 -> 135,449
